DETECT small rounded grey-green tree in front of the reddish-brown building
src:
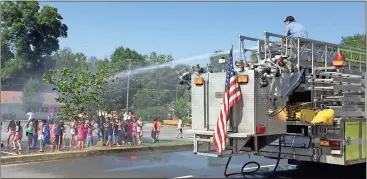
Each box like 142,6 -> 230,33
22,78 -> 43,112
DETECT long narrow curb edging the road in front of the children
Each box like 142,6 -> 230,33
1,141 -> 193,165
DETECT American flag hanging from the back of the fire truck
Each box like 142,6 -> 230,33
213,47 -> 242,155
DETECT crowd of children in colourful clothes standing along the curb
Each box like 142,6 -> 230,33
3,113 -> 147,151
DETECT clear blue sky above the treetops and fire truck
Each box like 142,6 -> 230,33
41,2 -> 366,63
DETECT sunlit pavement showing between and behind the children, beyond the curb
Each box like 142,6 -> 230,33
1,122 -> 193,156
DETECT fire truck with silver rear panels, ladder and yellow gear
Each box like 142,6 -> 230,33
179,32 -> 366,178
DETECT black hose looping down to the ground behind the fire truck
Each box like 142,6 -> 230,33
224,137 -> 282,179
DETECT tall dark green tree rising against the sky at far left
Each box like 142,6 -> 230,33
0,1 -> 68,89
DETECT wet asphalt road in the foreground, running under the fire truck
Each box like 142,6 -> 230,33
1,151 -> 366,179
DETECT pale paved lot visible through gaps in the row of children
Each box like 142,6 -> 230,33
1,121 -> 193,156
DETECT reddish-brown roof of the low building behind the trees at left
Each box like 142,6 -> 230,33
0,91 -> 60,105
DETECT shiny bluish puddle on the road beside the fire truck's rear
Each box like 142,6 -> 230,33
104,151 -> 295,173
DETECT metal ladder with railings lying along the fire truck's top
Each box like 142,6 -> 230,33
239,32 -> 366,72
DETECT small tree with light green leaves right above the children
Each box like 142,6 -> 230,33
43,68 -> 113,120
